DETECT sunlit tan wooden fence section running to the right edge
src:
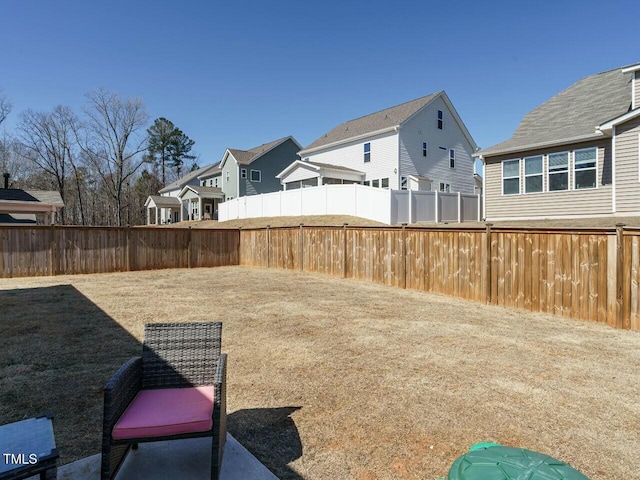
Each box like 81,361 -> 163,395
240,224 -> 640,330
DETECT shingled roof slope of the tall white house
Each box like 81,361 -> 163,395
300,92 -> 443,154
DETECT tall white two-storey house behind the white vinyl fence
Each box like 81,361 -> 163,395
278,91 -> 477,194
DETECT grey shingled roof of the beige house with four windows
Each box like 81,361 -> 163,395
478,67 -> 631,157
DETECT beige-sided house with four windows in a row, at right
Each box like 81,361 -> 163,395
477,64 -> 640,220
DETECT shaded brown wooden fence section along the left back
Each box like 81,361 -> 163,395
0,226 -> 239,277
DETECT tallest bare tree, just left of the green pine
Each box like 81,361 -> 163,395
78,89 -> 148,225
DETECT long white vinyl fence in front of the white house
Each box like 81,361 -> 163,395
218,184 -> 482,225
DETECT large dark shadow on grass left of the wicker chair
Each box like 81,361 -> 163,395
0,285 -> 141,463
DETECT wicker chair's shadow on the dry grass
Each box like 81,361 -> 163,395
227,407 -> 302,480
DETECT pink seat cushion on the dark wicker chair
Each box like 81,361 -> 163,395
112,386 -> 213,440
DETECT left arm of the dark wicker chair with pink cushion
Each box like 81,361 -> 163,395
103,357 -> 142,435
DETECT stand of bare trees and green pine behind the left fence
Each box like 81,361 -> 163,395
0,89 -> 198,226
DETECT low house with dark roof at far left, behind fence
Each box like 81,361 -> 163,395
0,173 -> 64,226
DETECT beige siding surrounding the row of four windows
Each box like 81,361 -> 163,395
485,140 -> 613,220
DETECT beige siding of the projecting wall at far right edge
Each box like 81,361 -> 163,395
615,114 -> 640,214
